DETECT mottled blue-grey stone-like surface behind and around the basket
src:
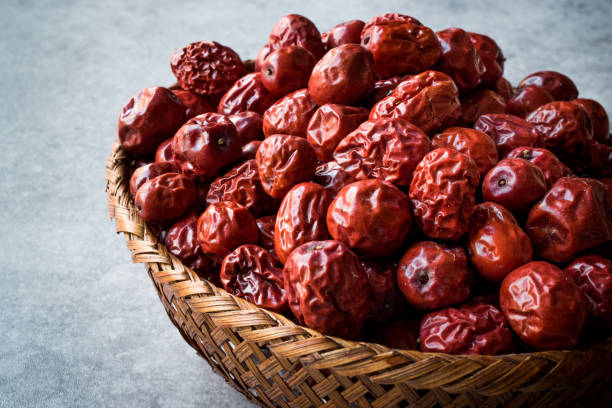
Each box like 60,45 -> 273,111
0,0 -> 612,407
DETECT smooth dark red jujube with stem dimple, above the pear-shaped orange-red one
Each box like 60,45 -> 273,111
482,159 -> 547,214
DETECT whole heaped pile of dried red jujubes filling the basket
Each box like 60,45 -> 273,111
118,13 -> 612,355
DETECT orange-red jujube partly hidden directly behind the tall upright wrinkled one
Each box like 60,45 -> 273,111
431,127 -> 497,178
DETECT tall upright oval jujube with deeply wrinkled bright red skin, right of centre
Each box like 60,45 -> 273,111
409,147 -> 479,241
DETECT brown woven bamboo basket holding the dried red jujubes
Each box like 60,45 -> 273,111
106,142 -> 612,408
